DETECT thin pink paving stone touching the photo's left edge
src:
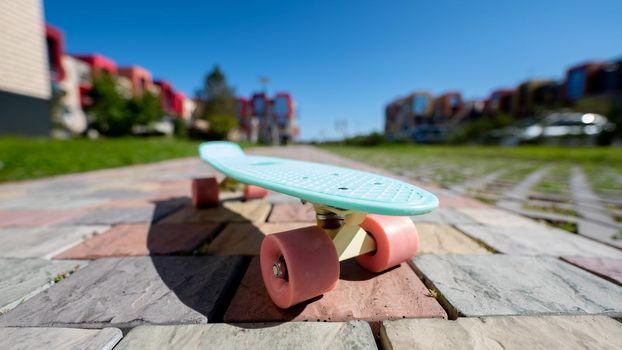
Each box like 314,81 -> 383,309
0,209 -> 88,227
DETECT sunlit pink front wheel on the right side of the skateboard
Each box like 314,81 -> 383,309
356,214 -> 419,272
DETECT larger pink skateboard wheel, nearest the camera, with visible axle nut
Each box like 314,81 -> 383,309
260,226 -> 339,309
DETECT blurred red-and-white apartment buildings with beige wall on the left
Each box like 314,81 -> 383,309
0,0 -> 195,136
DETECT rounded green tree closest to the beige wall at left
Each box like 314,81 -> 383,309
86,72 -> 134,136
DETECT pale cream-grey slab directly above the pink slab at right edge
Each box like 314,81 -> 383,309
456,224 -> 622,258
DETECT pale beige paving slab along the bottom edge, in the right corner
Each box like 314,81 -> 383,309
381,316 -> 622,350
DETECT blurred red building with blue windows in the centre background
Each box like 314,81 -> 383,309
236,92 -> 299,144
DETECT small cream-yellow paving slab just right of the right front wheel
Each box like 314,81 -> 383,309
417,223 -> 490,254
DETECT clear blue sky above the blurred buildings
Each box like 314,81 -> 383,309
44,0 -> 622,139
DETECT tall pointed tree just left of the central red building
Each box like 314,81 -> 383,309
197,66 -> 238,140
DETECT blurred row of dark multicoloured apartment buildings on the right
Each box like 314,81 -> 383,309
384,60 -> 622,143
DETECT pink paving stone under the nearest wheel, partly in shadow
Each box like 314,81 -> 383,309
224,257 -> 447,322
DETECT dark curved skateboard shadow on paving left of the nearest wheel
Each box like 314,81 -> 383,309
147,197 -> 304,326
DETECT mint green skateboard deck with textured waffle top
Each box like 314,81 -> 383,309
199,141 -> 438,216
